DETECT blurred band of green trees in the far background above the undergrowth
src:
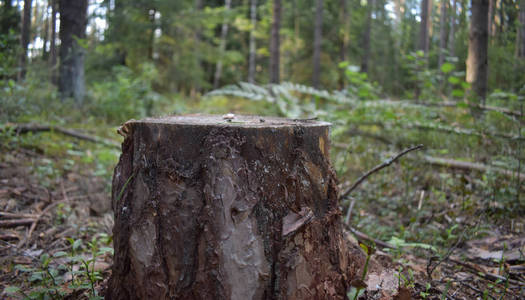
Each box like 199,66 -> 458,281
0,0 -> 525,122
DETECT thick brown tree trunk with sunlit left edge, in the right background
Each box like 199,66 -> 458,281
467,0 -> 489,104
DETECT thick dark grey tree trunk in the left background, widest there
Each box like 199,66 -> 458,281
58,0 -> 88,104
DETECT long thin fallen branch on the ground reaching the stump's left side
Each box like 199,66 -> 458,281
2,124 -> 120,149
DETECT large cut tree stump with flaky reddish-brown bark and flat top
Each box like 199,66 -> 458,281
106,115 -> 358,299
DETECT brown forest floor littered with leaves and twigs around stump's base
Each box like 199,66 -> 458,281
0,127 -> 525,299
